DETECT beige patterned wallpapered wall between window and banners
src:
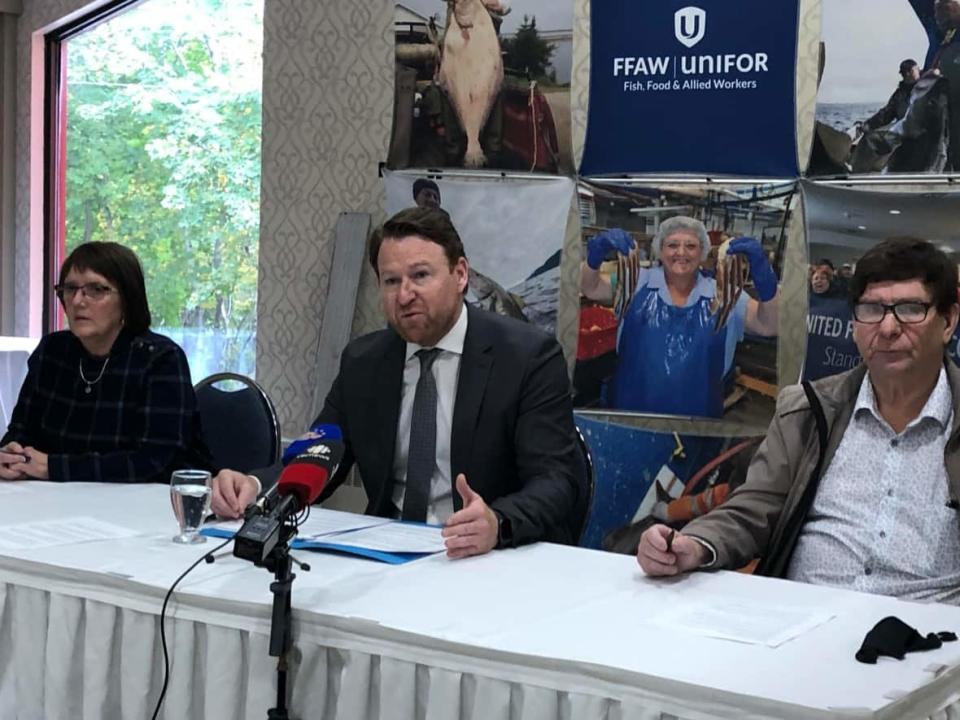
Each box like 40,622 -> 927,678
257,0 -> 394,434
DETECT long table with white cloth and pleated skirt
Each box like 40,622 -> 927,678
0,482 -> 960,720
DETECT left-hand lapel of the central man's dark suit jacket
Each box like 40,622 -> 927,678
371,333 -> 406,514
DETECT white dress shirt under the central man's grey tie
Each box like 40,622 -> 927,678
391,306 -> 467,525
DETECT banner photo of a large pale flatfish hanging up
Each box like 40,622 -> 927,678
387,0 -> 573,174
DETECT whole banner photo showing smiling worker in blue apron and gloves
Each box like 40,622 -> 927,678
574,183 -> 794,424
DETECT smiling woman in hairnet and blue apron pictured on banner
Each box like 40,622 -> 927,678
580,216 -> 779,417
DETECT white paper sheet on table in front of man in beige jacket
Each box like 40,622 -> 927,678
651,600 -> 834,648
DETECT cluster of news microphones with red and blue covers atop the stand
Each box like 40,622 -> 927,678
233,426 -> 343,565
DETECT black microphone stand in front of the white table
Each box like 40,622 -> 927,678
262,506 -> 310,720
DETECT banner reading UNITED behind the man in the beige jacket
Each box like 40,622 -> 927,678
801,181 -> 960,380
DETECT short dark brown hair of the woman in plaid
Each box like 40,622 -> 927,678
60,241 -> 151,335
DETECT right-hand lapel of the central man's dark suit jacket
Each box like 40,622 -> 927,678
450,305 -> 493,510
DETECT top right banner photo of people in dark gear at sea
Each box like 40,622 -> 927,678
807,0 -> 960,175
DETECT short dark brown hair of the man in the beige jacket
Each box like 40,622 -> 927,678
850,237 -> 957,315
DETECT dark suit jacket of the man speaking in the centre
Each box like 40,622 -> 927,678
314,306 -> 588,544
